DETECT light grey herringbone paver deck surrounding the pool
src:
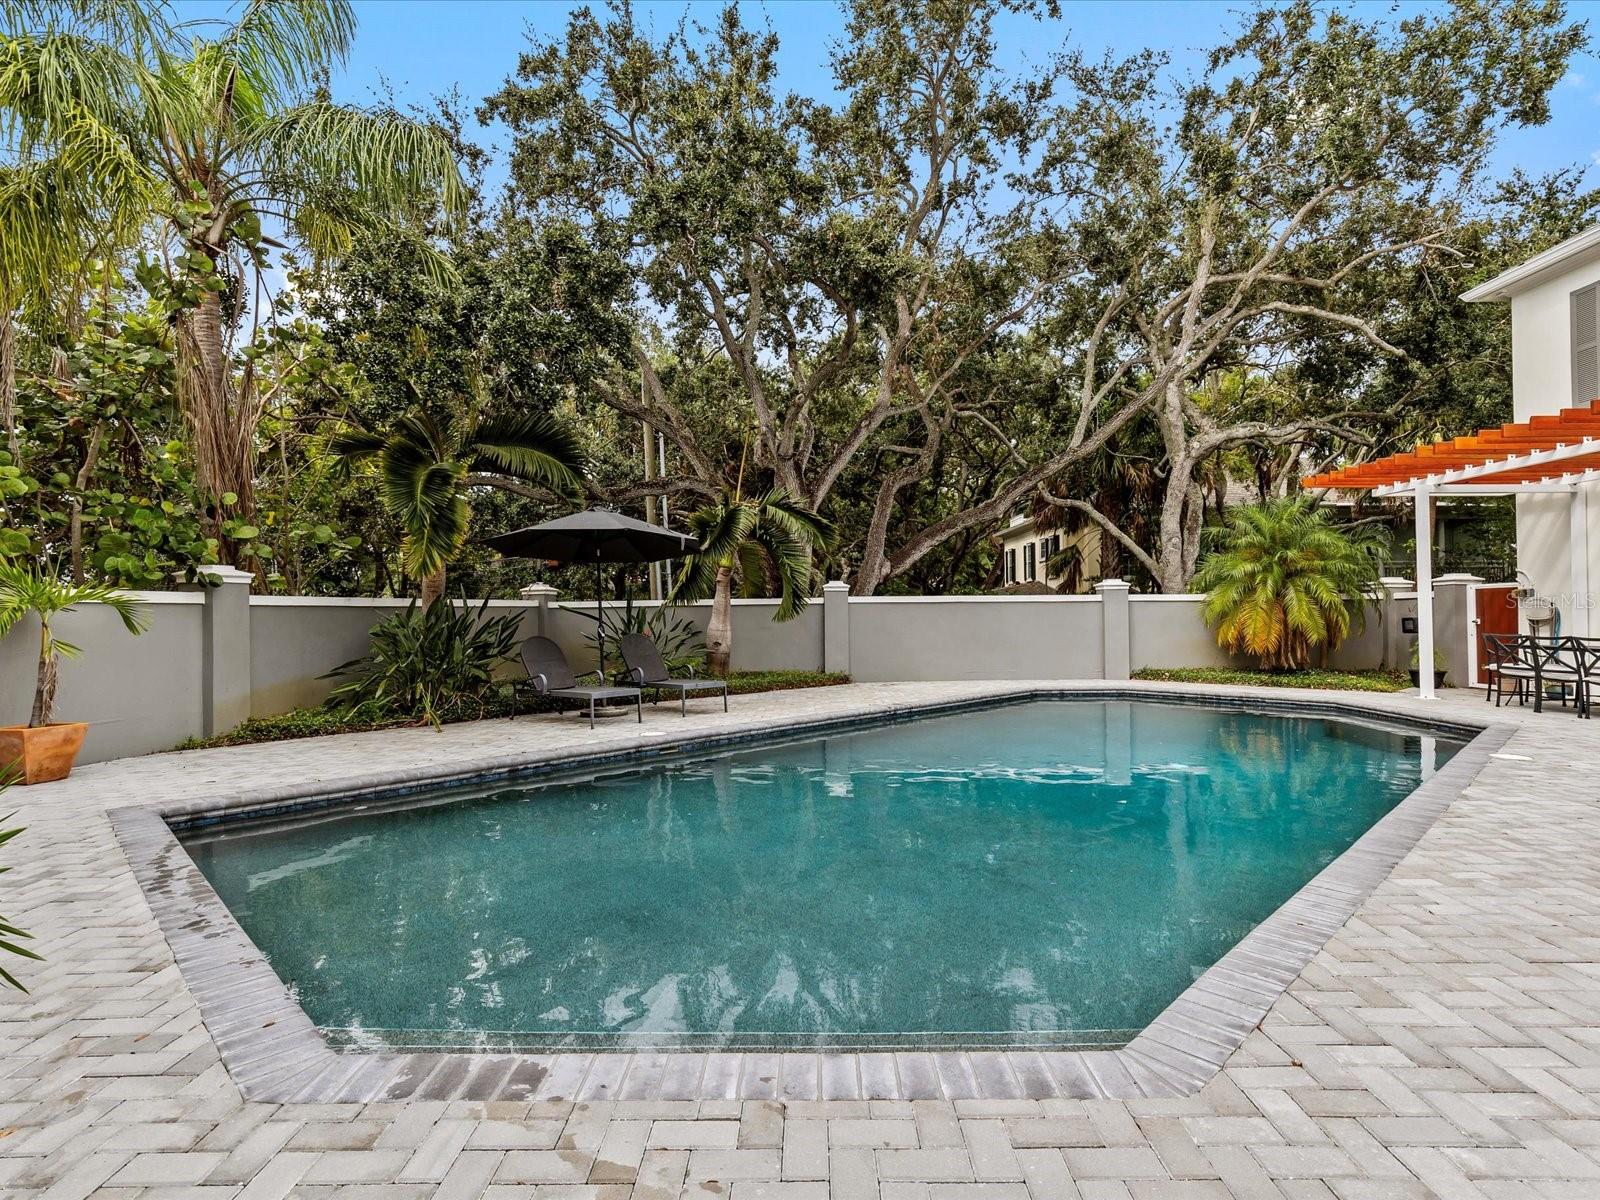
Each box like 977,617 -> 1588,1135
0,682 -> 1600,1200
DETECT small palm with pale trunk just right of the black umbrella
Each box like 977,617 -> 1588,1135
669,488 -> 834,675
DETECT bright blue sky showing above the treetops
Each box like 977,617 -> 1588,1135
178,0 -> 1600,188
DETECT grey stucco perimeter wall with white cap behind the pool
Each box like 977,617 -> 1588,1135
0,589 -> 1420,762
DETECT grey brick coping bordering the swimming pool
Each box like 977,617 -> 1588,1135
109,683 -> 1515,1102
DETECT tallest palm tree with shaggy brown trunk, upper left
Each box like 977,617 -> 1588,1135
0,0 -> 462,555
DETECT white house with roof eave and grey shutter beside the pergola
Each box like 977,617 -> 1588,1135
1462,226 -> 1600,627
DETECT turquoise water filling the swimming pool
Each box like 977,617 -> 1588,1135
187,701 -> 1459,1048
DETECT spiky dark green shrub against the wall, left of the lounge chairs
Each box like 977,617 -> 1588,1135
323,600 -> 522,725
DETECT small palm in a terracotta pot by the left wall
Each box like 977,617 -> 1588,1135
0,563 -> 144,784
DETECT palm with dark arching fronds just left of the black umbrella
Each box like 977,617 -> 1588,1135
330,401 -> 584,610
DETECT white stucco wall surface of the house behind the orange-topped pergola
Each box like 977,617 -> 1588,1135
1510,261 -> 1600,635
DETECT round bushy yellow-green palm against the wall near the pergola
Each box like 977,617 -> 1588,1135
1194,496 -> 1382,670
